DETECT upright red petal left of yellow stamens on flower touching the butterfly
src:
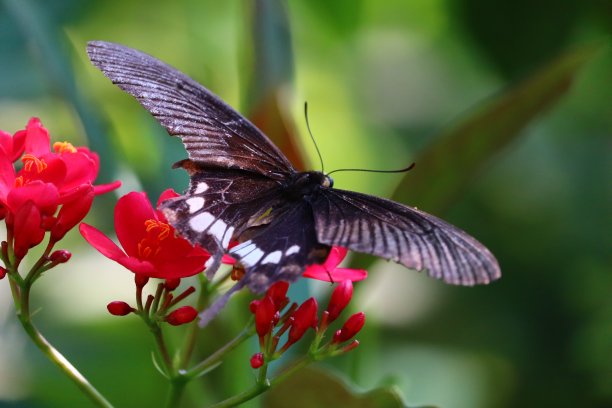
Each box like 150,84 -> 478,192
115,192 -> 157,257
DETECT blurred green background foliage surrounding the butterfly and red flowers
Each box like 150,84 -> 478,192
0,0 -> 612,408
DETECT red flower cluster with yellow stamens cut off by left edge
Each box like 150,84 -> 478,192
0,118 -> 120,263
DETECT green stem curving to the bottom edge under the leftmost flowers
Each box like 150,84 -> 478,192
11,271 -> 112,408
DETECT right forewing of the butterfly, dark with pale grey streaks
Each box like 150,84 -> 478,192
313,189 -> 501,286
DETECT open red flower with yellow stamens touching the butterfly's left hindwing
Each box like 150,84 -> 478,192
79,190 -> 210,279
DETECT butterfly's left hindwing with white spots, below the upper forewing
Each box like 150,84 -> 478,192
160,165 -> 279,273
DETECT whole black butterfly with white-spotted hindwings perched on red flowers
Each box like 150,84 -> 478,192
87,41 -> 500,322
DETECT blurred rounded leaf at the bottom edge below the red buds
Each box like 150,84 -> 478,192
263,367 -> 432,408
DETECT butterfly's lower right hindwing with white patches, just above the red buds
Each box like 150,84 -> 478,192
229,202 -> 330,293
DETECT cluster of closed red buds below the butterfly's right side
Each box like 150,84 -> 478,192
250,280 -> 365,368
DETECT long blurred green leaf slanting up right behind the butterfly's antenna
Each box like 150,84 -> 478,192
393,45 -> 600,213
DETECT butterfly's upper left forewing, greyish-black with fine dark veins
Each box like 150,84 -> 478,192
87,41 -> 295,179
